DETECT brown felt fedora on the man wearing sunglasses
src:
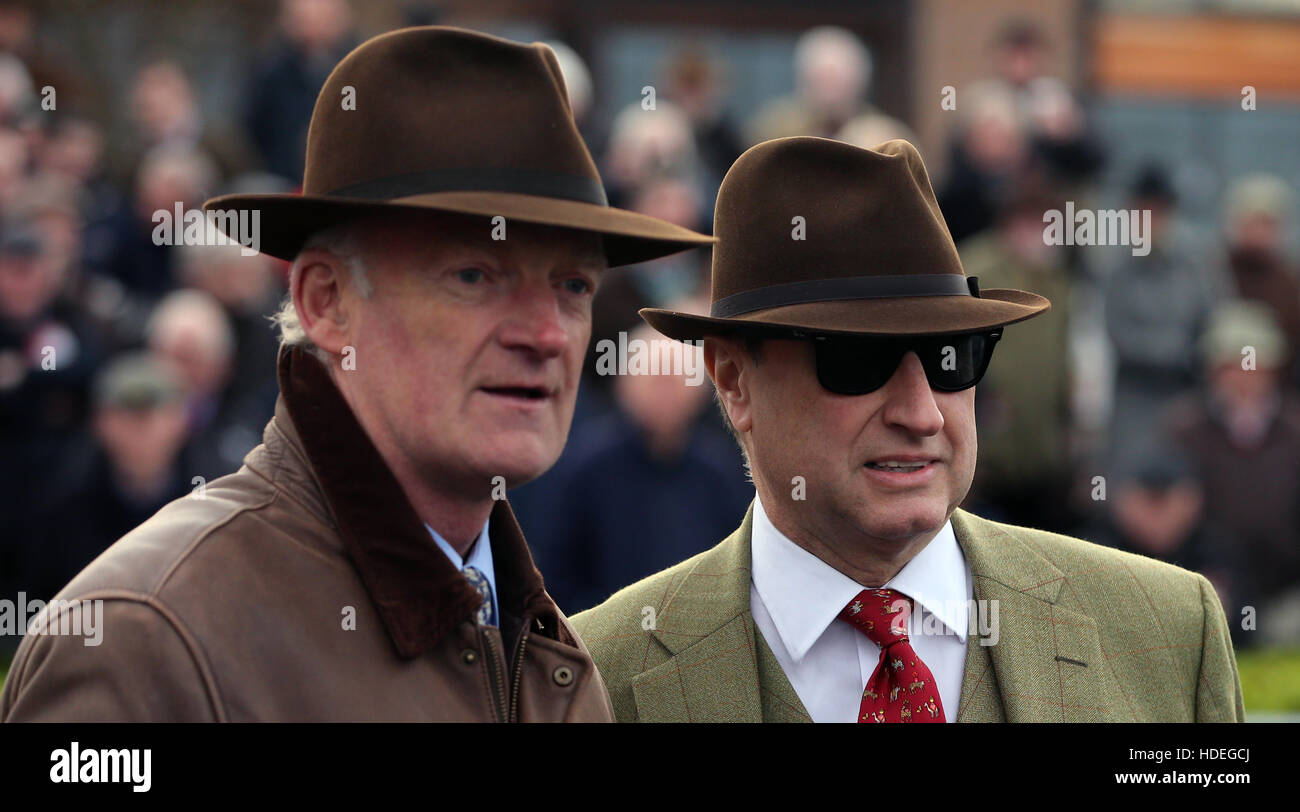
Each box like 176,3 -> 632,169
641,136 -> 1050,340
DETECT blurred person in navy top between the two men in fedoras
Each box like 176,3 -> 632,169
511,311 -> 754,612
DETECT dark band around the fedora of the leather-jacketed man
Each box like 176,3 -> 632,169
328,166 -> 610,207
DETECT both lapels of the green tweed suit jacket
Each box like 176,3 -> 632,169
633,505 -> 1108,722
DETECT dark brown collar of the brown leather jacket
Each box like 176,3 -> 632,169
274,347 -> 559,659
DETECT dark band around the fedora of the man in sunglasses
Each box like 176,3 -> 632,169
709,274 -> 979,318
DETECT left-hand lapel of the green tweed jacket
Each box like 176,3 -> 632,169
632,505 -> 811,722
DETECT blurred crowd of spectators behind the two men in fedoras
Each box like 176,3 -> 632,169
0,0 -> 1300,646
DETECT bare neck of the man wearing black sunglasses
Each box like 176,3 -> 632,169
759,480 -> 944,587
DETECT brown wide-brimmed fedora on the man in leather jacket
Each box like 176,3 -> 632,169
203,26 -> 714,265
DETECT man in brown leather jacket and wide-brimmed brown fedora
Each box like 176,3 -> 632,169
0,27 -> 710,721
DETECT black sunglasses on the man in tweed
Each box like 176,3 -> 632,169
803,330 -> 1002,395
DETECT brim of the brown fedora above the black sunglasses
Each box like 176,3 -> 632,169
640,288 -> 1052,340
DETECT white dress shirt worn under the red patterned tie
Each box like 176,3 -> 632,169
749,495 -> 972,722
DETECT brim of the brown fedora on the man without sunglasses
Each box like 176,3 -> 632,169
203,192 -> 715,268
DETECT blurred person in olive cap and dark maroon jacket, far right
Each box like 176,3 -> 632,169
1164,300 -> 1300,644
